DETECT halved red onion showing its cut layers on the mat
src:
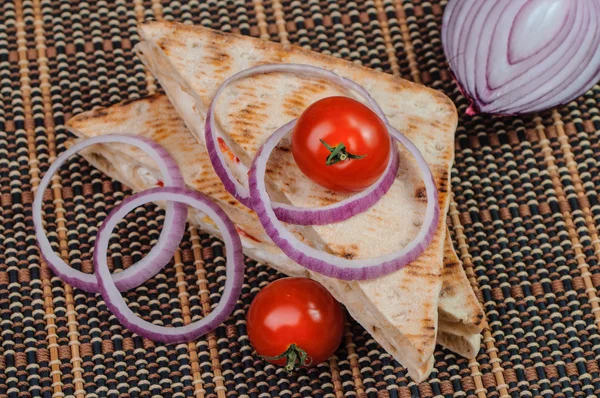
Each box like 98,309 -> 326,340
442,0 -> 600,116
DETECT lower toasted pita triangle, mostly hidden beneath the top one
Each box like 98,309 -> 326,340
68,96 -> 481,374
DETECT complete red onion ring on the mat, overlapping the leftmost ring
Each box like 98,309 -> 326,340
94,187 -> 244,343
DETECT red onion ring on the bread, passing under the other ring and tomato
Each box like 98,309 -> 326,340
204,64 -> 398,225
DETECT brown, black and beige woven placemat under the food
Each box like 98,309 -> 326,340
0,0 -> 600,397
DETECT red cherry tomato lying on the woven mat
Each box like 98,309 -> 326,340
246,278 -> 344,371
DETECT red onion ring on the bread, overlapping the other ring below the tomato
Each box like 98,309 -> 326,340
249,121 -> 440,280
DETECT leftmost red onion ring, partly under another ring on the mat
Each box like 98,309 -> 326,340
32,135 -> 187,293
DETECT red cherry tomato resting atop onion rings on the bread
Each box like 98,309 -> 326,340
292,97 -> 390,192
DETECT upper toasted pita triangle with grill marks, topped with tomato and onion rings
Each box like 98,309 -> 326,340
139,22 -> 457,381
